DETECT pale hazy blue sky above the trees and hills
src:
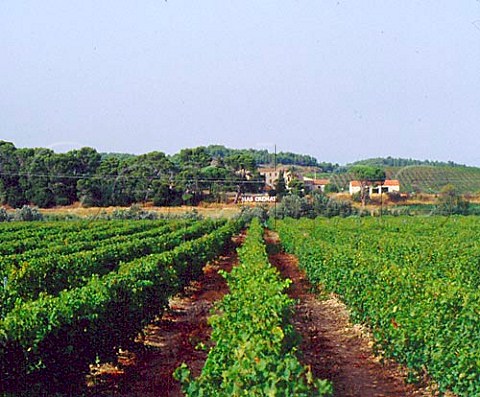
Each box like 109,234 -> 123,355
0,0 -> 480,166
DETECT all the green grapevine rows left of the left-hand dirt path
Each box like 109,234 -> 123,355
0,220 -> 238,391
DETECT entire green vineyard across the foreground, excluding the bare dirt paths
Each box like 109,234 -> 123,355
0,217 -> 480,397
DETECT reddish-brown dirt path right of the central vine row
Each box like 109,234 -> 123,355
266,230 -> 448,397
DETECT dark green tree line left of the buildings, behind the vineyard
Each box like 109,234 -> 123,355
0,141 -> 284,208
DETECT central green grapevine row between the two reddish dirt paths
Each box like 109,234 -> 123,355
175,219 -> 331,396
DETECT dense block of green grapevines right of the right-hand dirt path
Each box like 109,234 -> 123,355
278,217 -> 480,396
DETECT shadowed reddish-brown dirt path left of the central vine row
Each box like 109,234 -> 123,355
87,235 -> 244,397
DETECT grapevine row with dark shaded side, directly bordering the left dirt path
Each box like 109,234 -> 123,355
0,222 -> 238,390
